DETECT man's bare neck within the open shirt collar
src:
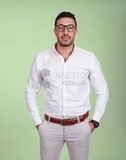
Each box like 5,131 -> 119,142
55,43 -> 74,61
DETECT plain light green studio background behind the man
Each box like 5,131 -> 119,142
0,0 -> 126,160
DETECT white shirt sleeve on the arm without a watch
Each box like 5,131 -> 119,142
25,56 -> 42,126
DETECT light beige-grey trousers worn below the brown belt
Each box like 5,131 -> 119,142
38,118 -> 91,160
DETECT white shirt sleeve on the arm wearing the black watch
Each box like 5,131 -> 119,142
90,54 -> 109,122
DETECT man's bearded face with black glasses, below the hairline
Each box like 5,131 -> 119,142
54,17 -> 77,47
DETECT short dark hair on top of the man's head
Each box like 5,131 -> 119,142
54,11 -> 77,27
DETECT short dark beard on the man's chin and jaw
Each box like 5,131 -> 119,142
57,36 -> 74,47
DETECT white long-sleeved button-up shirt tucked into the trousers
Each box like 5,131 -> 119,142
25,47 -> 109,125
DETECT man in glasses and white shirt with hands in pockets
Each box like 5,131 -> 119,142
25,12 -> 108,160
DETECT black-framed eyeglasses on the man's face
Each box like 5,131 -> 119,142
55,24 -> 76,32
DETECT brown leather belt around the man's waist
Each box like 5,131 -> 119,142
45,111 -> 89,126
